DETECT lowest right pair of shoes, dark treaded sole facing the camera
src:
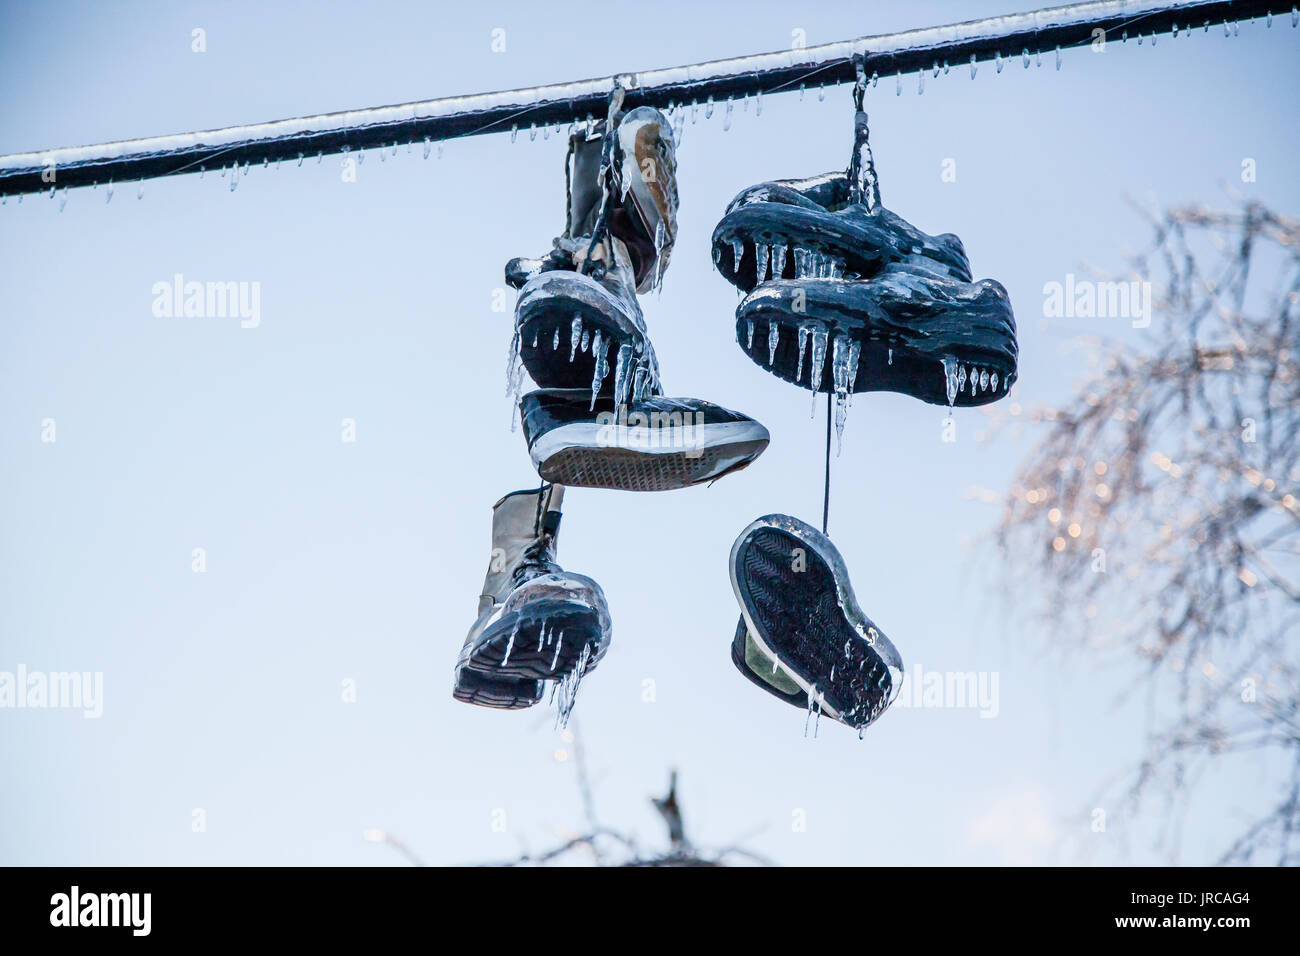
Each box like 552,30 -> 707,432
731,515 -> 904,731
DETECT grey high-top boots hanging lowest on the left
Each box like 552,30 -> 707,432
454,485 -> 612,706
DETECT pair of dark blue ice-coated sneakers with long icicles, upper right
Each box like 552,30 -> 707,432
712,173 -> 1018,406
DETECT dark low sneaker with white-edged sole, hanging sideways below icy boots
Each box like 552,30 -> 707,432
519,390 -> 770,492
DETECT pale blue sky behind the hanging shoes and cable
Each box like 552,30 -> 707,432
0,0 -> 1300,865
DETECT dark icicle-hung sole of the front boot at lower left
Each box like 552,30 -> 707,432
464,601 -> 605,680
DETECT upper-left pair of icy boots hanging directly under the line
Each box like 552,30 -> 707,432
506,107 -> 677,394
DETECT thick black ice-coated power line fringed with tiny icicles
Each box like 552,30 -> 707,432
0,0 -> 1279,195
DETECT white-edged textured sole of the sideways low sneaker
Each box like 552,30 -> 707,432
529,421 -> 770,492
